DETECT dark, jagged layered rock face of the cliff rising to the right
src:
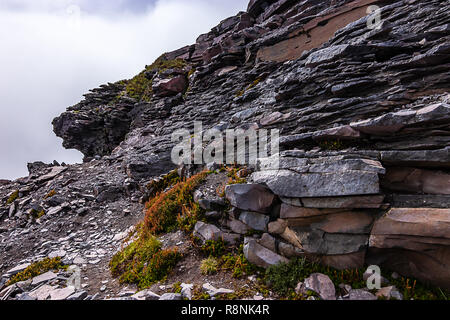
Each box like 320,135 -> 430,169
49,0 -> 450,288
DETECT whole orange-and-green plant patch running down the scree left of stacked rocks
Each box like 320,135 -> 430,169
110,172 -> 208,289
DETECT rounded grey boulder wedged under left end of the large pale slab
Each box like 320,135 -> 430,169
225,184 -> 275,213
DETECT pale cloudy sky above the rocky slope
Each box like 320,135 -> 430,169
0,0 -> 248,179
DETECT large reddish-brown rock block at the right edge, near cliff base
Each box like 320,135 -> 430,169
368,208 -> 450,289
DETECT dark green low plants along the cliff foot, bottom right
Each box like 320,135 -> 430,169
263,258 -> 448,300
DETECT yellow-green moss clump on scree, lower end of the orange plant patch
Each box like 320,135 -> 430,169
109,235 -> 181,289
